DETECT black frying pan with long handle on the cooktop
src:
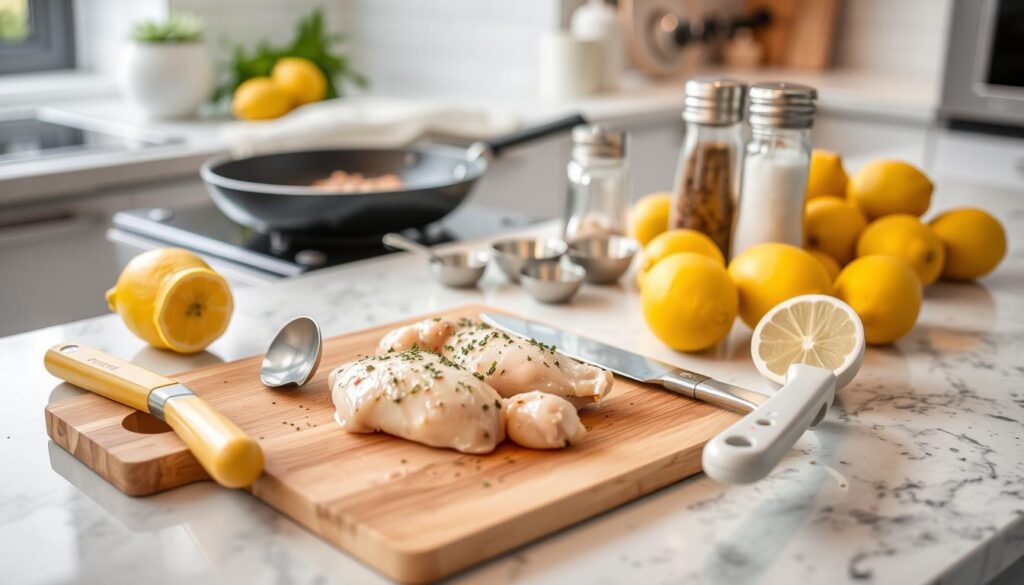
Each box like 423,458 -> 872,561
200,114 -> 587,237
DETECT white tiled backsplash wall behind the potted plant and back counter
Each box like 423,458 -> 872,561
76,0 -> 953,100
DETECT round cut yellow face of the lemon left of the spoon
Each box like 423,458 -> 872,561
156,267 -> 234,353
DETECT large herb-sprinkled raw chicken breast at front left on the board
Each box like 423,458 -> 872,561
329,349 -> 505,453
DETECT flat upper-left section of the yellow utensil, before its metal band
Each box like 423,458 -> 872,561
43,343 -> 175,412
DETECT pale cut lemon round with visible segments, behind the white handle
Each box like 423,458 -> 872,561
751,294 -> 864,389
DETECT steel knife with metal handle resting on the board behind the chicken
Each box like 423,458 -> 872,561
480,312 -> 767,413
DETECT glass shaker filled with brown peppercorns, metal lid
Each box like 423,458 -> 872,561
669,78 -> 745,257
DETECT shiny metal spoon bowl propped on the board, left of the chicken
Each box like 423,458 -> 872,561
259,317 -> 324,388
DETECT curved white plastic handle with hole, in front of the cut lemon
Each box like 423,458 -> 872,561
701,364 -> 836,484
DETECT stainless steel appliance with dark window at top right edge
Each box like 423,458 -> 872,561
939,0 -> 1024,131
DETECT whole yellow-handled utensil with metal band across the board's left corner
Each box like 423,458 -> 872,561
44,343 -> 263,488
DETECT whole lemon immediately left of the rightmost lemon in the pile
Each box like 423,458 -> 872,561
857,214 -> 946,286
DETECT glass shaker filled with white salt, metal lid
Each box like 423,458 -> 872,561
732,83 -> 817,256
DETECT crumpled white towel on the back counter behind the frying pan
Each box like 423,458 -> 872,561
219,96 -> 521,157
